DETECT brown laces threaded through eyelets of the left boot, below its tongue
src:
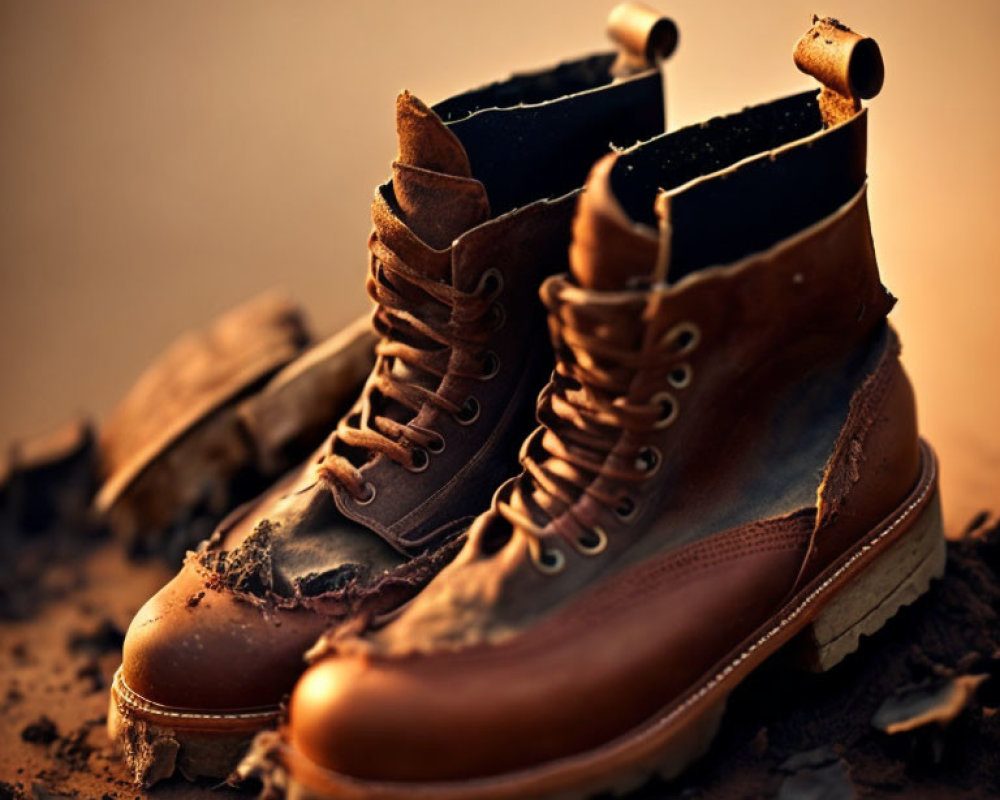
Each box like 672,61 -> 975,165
319,225 -> 502,502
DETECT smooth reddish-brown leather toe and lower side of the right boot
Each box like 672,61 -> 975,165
291,514 -> 812,780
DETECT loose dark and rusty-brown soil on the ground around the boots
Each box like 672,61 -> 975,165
0,515 -> 1000,800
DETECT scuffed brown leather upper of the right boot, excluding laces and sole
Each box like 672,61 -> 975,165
290,86 -> 916,781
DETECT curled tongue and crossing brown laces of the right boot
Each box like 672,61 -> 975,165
501,155 -> 672,531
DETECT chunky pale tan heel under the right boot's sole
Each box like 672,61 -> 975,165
792,491 -> 946,672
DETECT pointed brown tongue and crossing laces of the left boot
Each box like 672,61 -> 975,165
325,92 -> 490,484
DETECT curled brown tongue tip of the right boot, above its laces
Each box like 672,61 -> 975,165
569,153 -> 659,291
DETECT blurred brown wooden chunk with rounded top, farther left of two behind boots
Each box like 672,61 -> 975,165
96,294 -> 309,546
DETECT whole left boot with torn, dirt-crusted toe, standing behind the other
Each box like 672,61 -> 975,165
109,1 -> 676,784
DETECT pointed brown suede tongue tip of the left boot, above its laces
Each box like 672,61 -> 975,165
392,92 -> 490,255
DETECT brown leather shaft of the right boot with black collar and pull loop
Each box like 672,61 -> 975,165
535,21 -> 915,561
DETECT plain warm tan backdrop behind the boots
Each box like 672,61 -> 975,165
0,0 -> 1000,529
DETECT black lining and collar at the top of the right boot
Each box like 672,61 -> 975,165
611,91 -> 865,282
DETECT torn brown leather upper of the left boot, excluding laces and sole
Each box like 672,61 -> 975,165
117,51 -> 663,709
